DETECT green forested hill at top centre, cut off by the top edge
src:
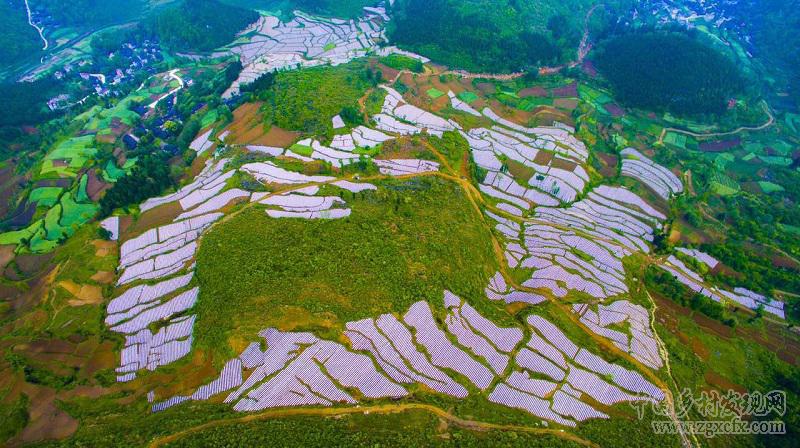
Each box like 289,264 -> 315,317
390,0 -> 591,72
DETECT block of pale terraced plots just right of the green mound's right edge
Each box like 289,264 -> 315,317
487,186 -> 664,299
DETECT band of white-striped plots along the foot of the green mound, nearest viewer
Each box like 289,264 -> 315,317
152,290 -> 664,427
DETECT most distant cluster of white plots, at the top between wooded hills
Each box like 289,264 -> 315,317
220,8 -> 385,98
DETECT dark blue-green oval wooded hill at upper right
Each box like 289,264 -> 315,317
595,32 -> 743,115
